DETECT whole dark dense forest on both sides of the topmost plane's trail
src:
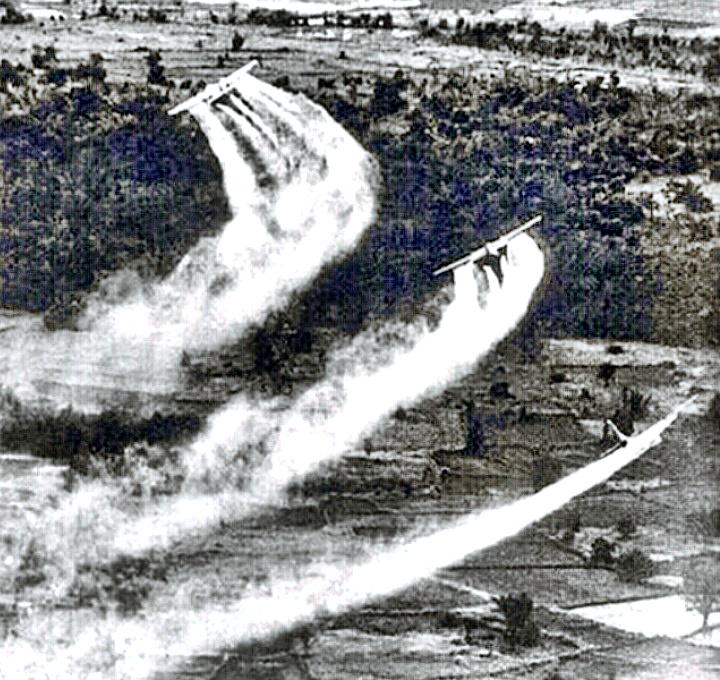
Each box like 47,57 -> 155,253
0,35 -> 720,340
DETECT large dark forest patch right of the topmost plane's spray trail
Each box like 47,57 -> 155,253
305,67 -> 715,346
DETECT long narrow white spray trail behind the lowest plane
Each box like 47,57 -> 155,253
0,400 -> 692,680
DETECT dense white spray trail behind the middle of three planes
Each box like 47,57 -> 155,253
115,234 -> 543,552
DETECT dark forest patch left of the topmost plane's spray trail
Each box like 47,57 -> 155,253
0,53 -> 228,323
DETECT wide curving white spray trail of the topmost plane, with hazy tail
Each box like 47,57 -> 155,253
0,76 -> 378,411
